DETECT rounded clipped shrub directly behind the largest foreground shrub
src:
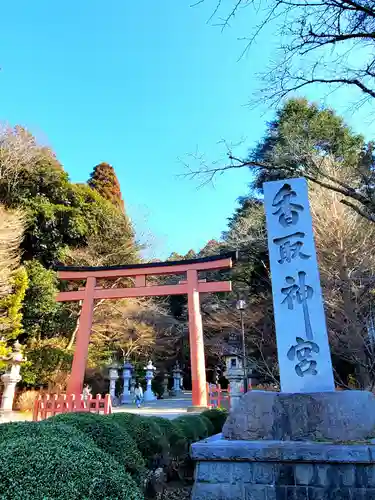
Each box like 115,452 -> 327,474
46,413 -> 145,480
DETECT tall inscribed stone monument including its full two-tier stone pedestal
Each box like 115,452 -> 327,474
192,179 -> 375,500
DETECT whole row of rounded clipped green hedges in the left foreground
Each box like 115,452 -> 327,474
0,411 -> 223,500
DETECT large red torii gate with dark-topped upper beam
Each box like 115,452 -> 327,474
57,252 -> 237,407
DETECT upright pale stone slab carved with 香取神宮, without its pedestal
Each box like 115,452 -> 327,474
263,179 -> 335,392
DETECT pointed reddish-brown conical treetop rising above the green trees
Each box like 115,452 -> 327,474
88,162 -> 125,212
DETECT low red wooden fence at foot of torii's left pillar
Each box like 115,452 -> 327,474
33,394 -> 112,422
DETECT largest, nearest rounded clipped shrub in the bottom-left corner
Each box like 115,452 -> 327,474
0,434 -> 143,500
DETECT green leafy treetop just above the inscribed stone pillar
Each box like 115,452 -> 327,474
249,99 -> 365,190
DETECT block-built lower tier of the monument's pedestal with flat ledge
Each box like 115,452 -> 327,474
192,435 -> 375,500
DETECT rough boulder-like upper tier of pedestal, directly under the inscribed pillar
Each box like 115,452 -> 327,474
223,391 -> 375,441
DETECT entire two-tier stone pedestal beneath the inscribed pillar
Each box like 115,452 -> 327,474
192,391 -> 375,500
